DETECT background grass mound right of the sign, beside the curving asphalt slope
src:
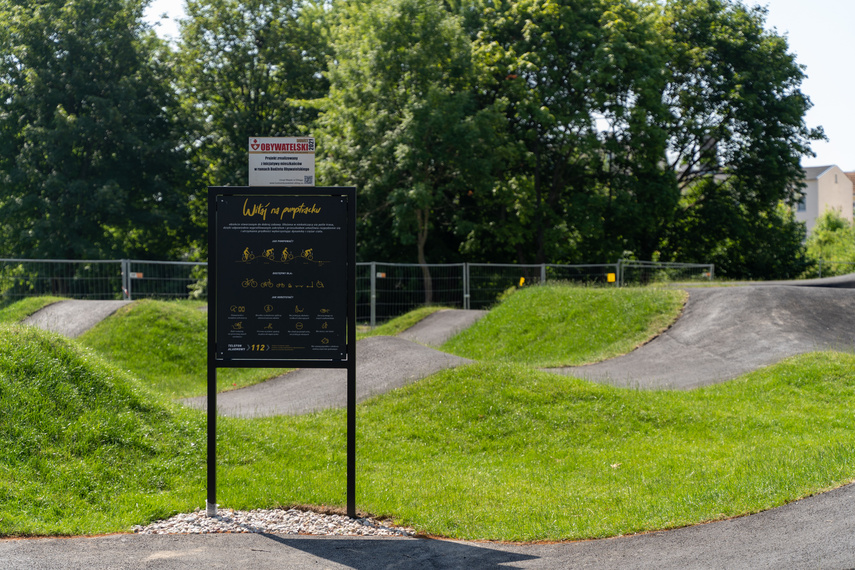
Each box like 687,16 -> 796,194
442,285 -> 687,367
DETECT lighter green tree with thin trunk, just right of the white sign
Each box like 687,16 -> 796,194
319,0 -> 495,302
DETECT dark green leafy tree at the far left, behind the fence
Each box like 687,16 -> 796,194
0,0 -> 192,259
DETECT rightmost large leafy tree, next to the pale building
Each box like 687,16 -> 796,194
661,0 -> 823,278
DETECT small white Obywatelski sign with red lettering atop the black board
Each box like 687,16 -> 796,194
248,137 -> 315,186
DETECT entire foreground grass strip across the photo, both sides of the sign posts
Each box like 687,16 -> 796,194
0,286 -> 855,540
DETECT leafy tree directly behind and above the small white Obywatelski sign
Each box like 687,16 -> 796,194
179,0 -> 328,187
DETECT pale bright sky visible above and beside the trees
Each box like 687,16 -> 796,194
146,0 -> 855,172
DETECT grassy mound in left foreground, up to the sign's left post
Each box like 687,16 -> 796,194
0,325 -> 205,535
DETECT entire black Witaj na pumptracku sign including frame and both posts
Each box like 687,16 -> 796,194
207,186 -> 356,518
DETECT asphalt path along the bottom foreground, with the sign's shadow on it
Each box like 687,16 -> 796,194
6,485 -> 855,570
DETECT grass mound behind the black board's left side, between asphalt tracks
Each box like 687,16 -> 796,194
78,300 -> 286,398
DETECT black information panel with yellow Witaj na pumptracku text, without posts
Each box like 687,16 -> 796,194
215,188 -> 349,361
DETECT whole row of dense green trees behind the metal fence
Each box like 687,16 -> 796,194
0,0 -> 823,281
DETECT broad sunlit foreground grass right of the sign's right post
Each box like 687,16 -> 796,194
350,353 -> 855,541
